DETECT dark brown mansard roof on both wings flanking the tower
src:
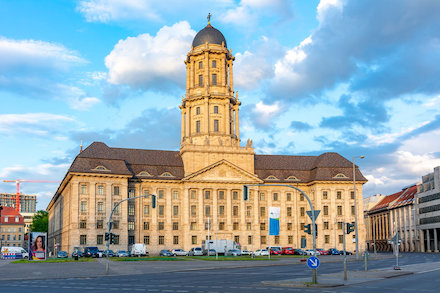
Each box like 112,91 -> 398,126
69,142 -> 367,183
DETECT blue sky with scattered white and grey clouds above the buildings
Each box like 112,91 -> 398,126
0,0 -> 440,209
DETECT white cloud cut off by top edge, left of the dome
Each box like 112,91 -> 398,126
78,0 -> 160,22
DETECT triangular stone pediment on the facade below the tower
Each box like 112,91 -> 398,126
183,160 -> 263,184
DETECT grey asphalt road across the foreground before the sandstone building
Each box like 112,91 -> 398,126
0,254 -> 440,293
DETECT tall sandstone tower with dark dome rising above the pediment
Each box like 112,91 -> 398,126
180,17 -> 254,174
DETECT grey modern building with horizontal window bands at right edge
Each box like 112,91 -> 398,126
417,167 -> 440,252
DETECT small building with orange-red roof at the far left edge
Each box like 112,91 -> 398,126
0,207 -> 25,247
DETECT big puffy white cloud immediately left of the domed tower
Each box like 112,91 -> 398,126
105,21 -> 196,89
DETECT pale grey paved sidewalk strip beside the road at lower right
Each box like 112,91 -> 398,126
261,262 -> 440,288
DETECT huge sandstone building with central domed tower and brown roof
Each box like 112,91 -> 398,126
47,20 -> 367,253
